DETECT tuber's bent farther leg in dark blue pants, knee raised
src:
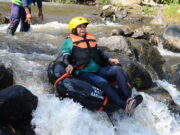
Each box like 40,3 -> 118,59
98,66 -> 131,100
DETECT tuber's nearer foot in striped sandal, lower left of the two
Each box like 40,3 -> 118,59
125,97 -> 136,116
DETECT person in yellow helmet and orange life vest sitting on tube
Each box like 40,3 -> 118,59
62,17 -> 142,115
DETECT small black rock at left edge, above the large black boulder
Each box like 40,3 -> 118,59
0,64 -> 13,90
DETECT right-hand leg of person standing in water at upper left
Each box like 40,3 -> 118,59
20,8 -> 30,32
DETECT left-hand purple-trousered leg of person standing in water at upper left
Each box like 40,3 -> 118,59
7,3 -> 20,35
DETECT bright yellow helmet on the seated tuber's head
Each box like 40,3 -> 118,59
69,17 -> 89,33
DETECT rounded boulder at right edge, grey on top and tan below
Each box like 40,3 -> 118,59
163,25 -> 180,52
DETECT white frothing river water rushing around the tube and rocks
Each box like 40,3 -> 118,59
0,2 -> 180,135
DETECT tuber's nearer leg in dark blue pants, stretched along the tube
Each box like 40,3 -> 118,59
78,72 -> 126,109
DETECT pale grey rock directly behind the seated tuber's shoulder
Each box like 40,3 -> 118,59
98,36 -> 134,56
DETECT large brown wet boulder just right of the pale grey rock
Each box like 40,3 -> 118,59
130,39 -> 165,79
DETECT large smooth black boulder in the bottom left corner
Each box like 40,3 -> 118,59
0,85 -> 38,135
